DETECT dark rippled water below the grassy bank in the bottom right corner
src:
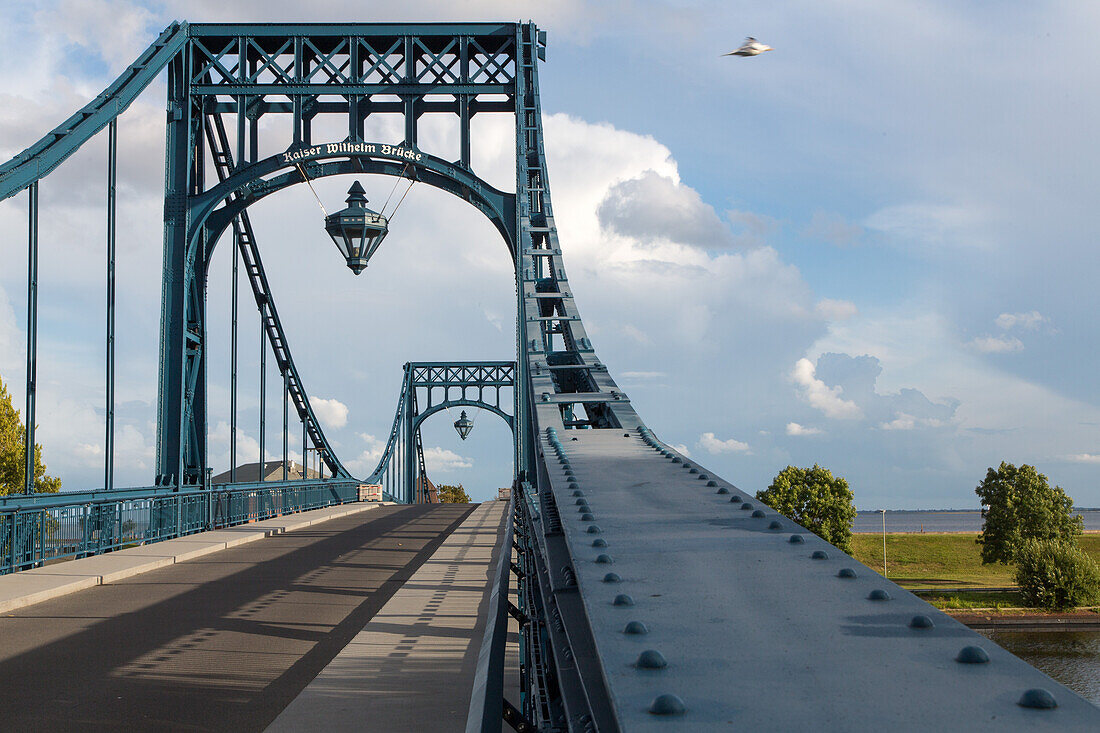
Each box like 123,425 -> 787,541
981,625 -> 1100,705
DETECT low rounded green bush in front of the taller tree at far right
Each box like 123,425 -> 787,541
1015,538 -> 1100,611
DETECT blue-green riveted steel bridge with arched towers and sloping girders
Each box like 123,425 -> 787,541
0,23 -> 1100,731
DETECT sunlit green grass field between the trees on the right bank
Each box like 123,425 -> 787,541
851,533 -> 1100,590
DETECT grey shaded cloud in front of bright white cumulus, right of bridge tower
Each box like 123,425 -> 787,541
596,171 -> 734,250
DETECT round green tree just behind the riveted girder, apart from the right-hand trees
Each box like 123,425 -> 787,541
757,463 -> 856,553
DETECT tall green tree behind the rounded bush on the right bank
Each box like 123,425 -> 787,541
975,461 -> 1084,565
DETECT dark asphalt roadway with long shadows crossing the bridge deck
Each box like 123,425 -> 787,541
0,504 -> 472,732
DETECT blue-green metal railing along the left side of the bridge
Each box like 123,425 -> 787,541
0,479 -> 359,573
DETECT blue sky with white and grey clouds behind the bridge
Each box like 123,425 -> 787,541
0,0 -> 1100,508
